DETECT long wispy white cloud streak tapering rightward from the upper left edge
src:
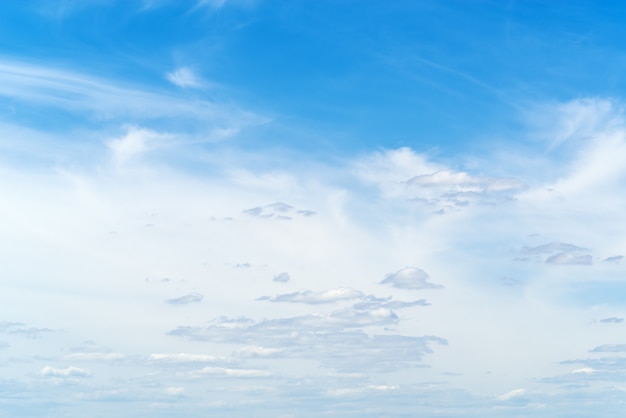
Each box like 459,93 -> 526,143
0,60 -> 267,141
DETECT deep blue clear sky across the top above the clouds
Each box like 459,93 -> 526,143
0,1 -> 625,156
